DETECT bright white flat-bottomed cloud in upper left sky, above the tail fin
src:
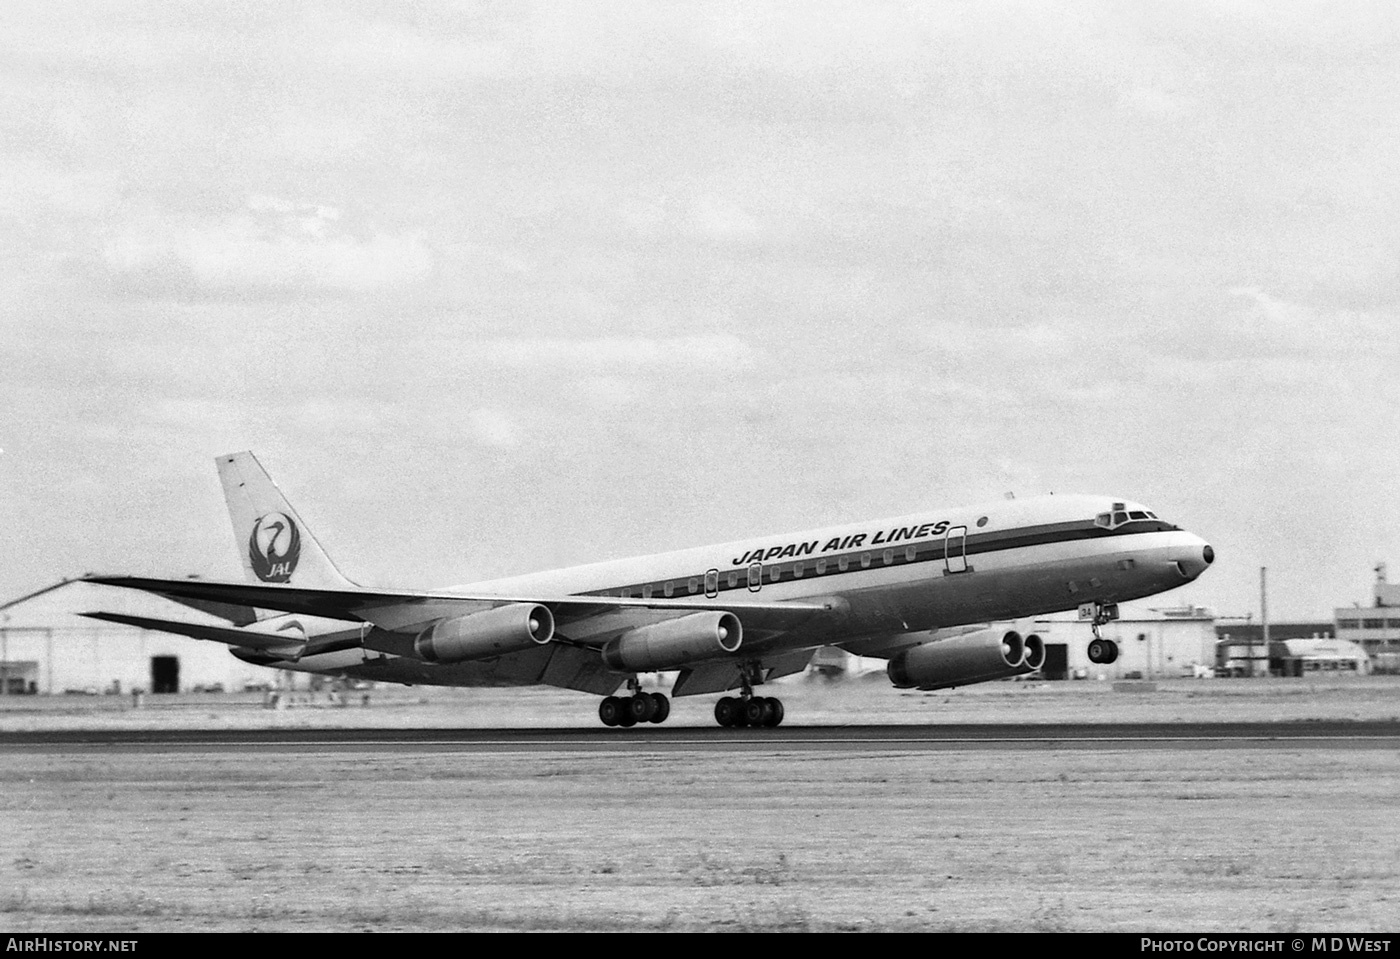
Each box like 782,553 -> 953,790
101,196 -> 434,293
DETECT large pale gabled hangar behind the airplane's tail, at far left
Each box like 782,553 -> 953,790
0,580 -> 286,696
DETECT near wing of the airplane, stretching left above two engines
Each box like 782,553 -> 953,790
85,575 -> 839,641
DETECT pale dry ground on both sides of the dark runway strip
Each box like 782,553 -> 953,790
0,679 -> 1400,932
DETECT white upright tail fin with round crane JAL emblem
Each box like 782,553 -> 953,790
214,452 -> 356,589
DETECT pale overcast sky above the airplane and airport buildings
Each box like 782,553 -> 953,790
0,0 -> 1400,620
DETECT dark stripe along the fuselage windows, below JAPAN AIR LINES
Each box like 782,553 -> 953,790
578,519 -> 1176,599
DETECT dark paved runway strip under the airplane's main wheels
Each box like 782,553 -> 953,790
0,721 -> 1400,753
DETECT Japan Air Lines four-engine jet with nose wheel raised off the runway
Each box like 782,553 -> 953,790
85,451 -> 1215,728
